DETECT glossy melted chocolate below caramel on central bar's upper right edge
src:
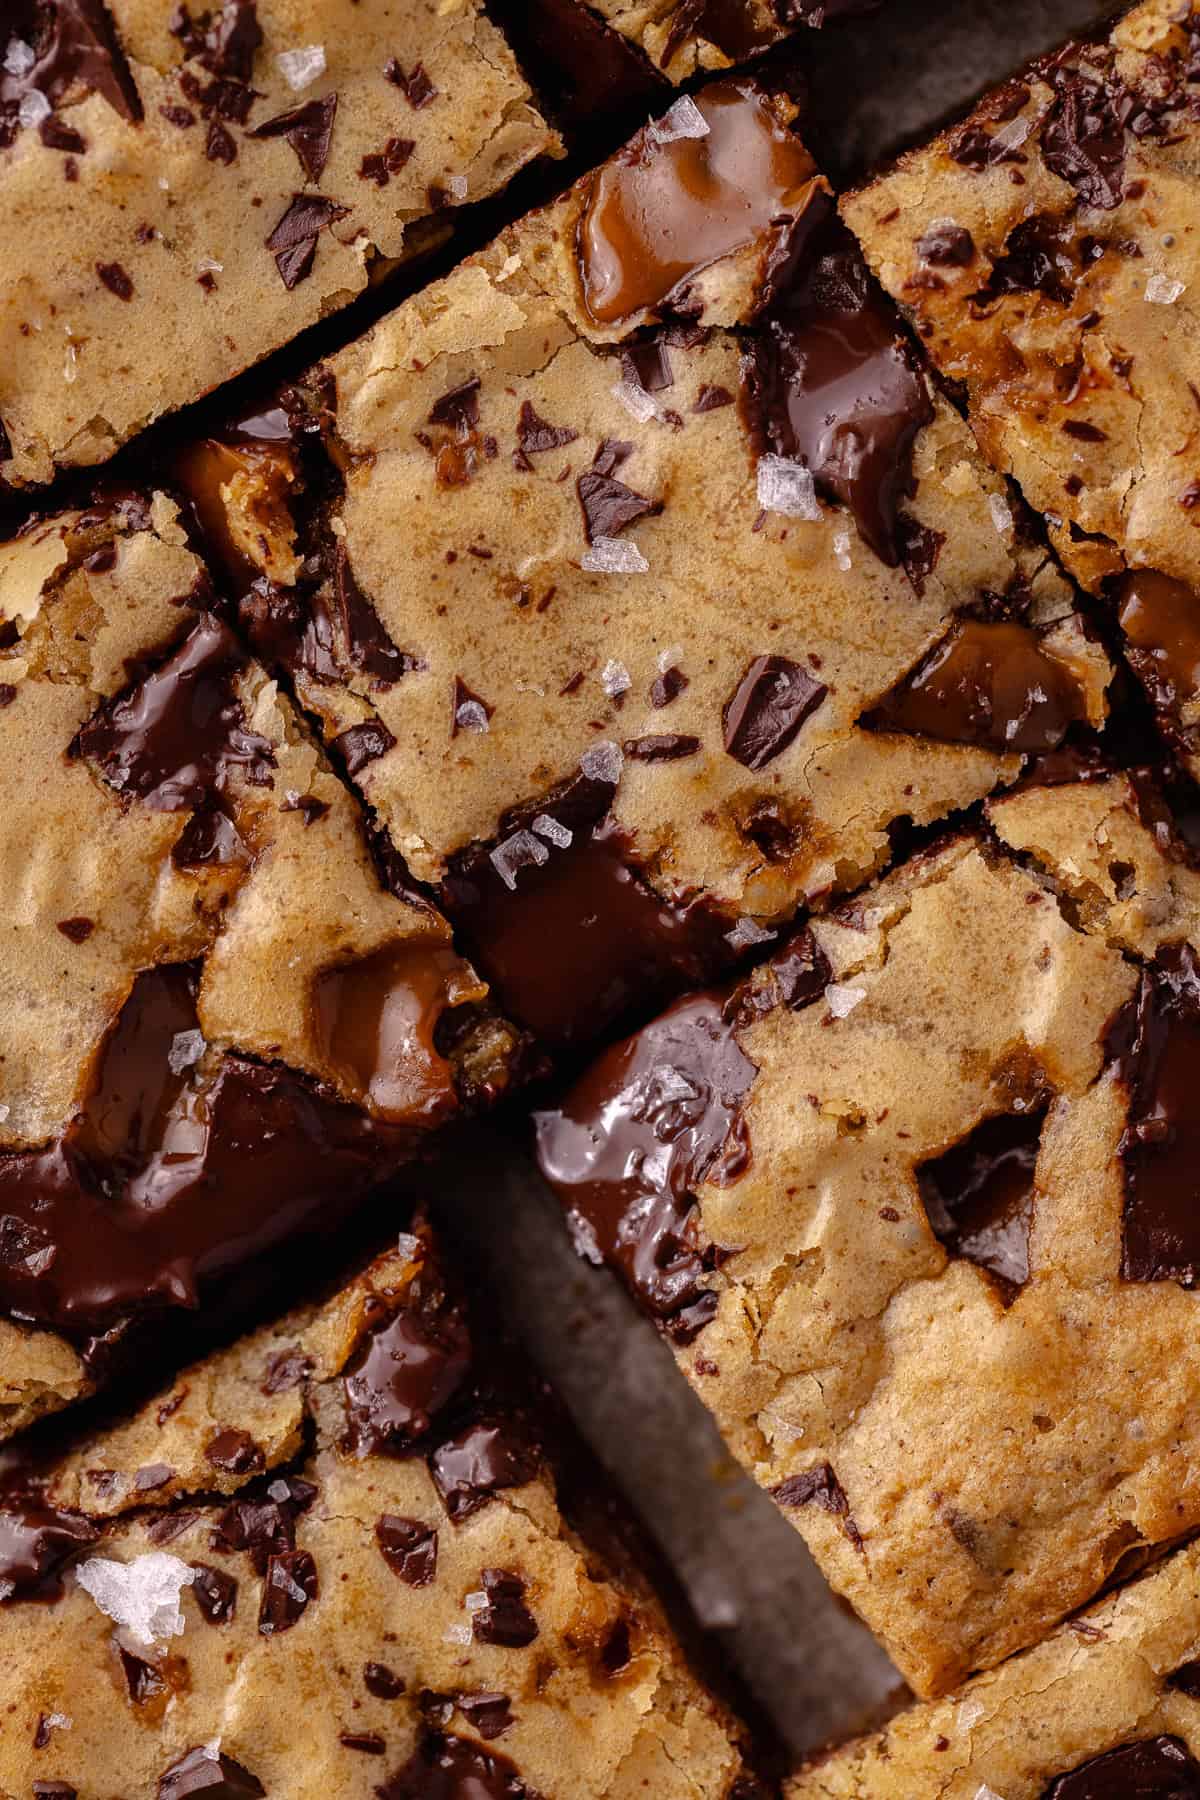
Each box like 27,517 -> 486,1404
747,206 -> 934,565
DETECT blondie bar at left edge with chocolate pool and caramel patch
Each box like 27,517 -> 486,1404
0,495 -> 513,1433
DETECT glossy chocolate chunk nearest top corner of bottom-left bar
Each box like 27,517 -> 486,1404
345,1305 -> 471,1456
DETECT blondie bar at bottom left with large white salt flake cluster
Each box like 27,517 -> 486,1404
0,1233 -> 755,1800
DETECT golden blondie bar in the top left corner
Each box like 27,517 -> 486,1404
0,0 -> 556,484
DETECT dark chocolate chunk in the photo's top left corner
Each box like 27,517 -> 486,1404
0,0 -> 142,122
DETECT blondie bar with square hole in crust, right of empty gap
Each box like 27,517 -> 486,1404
540,776 -> 1200,1694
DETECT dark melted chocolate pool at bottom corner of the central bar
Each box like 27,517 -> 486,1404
441,795 -> 732,1046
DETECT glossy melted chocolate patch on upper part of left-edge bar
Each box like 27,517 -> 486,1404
72,612 -> 275,812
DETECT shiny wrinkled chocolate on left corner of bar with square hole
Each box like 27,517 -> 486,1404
536,994 -> 757,1343
